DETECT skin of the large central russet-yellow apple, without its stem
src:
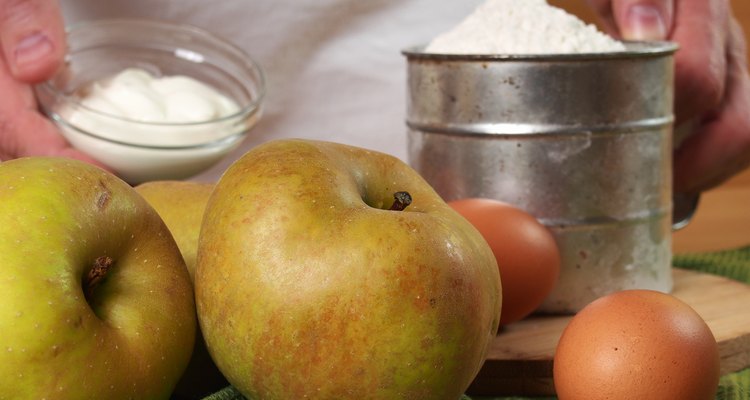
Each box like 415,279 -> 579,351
195,140 -> 501,400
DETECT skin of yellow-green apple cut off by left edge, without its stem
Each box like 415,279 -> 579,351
0,157 -> 197,399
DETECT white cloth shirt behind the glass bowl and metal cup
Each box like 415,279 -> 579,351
61,0 -> 480,181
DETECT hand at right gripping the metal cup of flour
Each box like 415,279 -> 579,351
589,0 -> 750,193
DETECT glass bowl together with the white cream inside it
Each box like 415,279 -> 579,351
36,19 -> 265,184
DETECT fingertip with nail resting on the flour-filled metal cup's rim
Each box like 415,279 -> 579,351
612,0 -> 674,40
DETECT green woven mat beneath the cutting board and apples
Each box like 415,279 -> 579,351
204,246 -> 750,400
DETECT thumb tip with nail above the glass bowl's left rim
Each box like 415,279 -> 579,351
0,0 -> 65,82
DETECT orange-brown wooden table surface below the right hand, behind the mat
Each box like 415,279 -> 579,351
672,169 -> 750,254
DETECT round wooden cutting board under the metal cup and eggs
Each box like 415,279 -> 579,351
467,269 -> 750,396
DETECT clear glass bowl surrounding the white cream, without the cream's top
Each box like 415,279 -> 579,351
36,19 -> 265,184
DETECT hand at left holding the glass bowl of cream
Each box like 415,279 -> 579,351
0,0 -> 106,166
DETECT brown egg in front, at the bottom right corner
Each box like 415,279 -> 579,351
553,290 -> 719,400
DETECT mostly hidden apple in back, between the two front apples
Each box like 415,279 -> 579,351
135,181 -> 229,399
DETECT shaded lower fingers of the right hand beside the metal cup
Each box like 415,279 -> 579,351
674,17 -> 750,193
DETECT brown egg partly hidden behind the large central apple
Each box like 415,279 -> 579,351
448,198 -> 560,325
